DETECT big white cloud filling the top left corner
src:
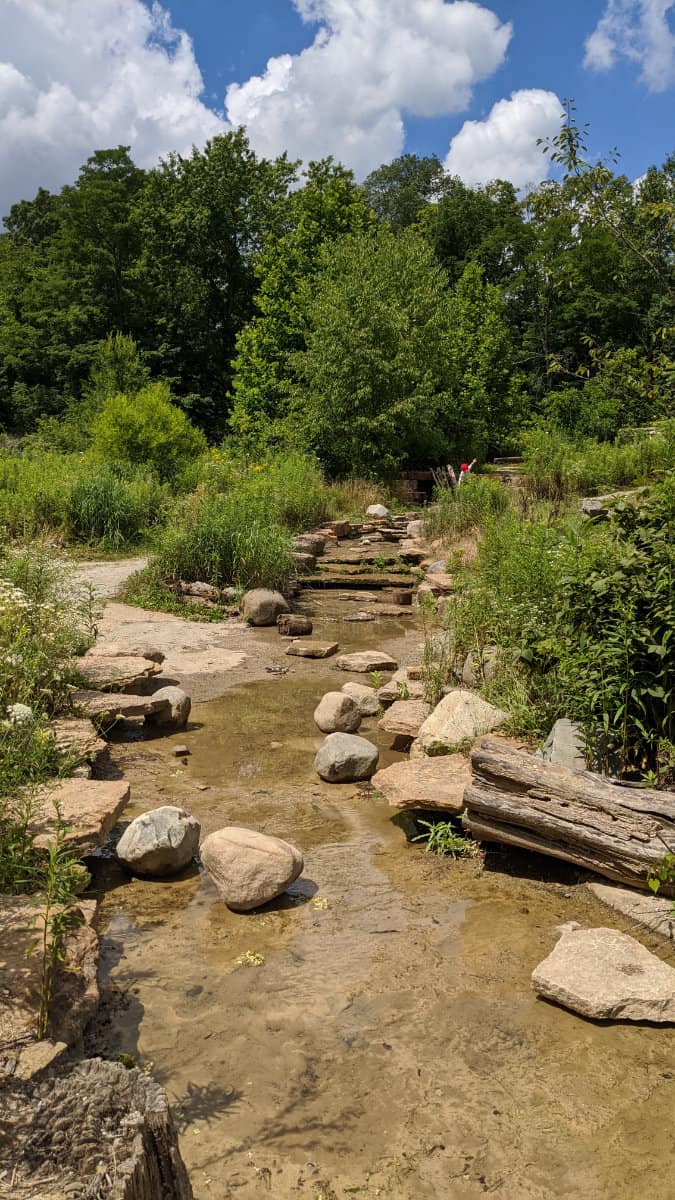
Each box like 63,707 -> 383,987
0,0 -> 227,214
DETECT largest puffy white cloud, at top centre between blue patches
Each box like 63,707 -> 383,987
226,0 -> 512,178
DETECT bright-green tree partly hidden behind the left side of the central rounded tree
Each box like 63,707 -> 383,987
225,158 -> 375,448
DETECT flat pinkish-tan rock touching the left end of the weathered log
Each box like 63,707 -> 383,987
371,754 -> 471,816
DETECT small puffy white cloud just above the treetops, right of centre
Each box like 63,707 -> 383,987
444,88 -> 562,188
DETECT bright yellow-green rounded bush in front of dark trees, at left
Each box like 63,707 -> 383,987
91,383 -> 207,480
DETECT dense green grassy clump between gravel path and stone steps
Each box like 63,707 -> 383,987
157,492 -> 294,588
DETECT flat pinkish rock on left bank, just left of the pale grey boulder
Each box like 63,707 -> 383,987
30,779 -> 130,857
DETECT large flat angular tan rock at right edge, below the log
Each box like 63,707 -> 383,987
532,929 -> 675,1024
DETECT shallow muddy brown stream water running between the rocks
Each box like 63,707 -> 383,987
91,595 -> 675,1200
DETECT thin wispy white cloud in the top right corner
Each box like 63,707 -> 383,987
584,0 -> 675,91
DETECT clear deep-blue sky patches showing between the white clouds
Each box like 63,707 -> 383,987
169,0 -> 675,179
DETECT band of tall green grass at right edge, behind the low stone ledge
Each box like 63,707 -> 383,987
524,420 -> 675,500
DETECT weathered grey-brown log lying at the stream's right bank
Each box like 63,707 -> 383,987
464,738 -> 675,895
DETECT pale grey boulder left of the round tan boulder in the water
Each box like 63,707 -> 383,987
117,804 -> 202,878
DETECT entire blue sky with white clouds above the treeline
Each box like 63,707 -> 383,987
0,0 -> 675,212
